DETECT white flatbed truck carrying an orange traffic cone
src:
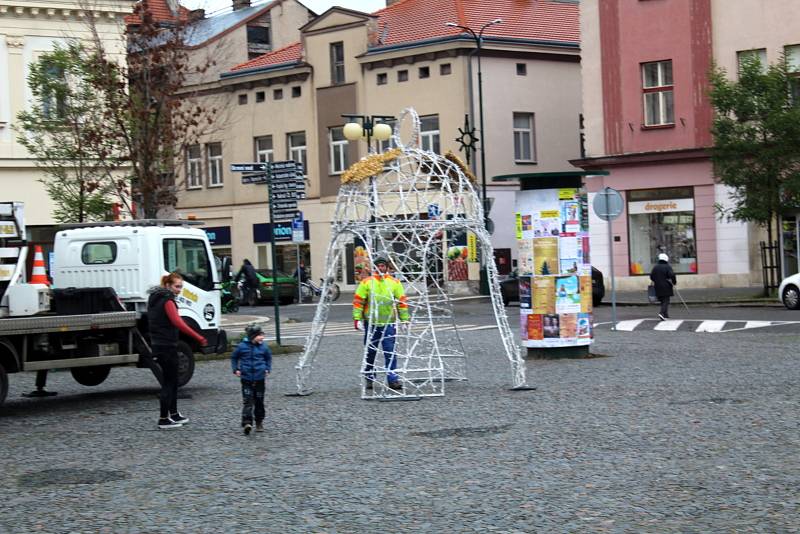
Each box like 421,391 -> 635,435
0,202 -> 228,404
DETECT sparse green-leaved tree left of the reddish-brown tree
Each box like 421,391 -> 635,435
17,42 -> 125,223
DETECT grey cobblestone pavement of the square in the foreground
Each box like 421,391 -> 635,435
0,324 -> 800,533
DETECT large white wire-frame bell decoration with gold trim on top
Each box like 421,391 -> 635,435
296,108 -> 529,400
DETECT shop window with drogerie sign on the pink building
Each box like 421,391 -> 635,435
628,187 -> 697,275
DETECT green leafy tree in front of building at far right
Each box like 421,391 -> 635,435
710,53 -> 800,250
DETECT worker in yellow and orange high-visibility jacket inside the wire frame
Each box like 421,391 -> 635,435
353,257 -> 409,390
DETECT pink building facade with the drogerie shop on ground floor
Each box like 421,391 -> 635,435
573,0 -> 752,289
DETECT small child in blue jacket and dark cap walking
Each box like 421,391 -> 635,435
231,324 -> 272,435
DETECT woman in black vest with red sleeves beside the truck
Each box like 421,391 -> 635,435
147,273 -> 208,429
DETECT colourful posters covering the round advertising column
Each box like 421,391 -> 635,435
516,188 -> 593,348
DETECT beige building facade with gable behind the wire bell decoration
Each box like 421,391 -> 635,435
178,2 -> 580,288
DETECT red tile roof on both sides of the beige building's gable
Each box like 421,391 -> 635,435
231,0 -> 580,71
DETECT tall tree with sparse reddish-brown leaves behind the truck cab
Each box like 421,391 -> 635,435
84,0 -> 221,218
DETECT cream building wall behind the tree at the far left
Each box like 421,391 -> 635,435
0,0 -> 133,225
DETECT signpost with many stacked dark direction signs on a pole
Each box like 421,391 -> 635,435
231,160 -> 306,345
